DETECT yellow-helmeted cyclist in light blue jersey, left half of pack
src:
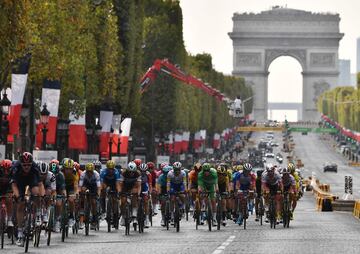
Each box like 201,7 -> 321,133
100,160 -> 121,218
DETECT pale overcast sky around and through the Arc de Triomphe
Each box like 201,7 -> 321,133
180,0 -> 360,120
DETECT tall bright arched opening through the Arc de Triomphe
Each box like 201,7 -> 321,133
267,56 -> 303,121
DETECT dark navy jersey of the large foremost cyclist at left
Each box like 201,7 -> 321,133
10,161 -> 40,196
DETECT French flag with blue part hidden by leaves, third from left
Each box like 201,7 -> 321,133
69,113 -> 87,151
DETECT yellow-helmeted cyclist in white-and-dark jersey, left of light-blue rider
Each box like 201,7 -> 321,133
79,163 -> 101,229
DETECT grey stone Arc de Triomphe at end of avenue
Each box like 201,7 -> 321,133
229,7 -> 343,121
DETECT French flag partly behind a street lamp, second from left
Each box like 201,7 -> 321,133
36,79 -> 61,147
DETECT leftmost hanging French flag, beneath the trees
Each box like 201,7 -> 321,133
9,57 -> 30,135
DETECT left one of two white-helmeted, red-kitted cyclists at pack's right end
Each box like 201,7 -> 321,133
261,164 -> 282,222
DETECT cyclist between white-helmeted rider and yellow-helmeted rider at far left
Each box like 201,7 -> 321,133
49,161 -> 66,232
